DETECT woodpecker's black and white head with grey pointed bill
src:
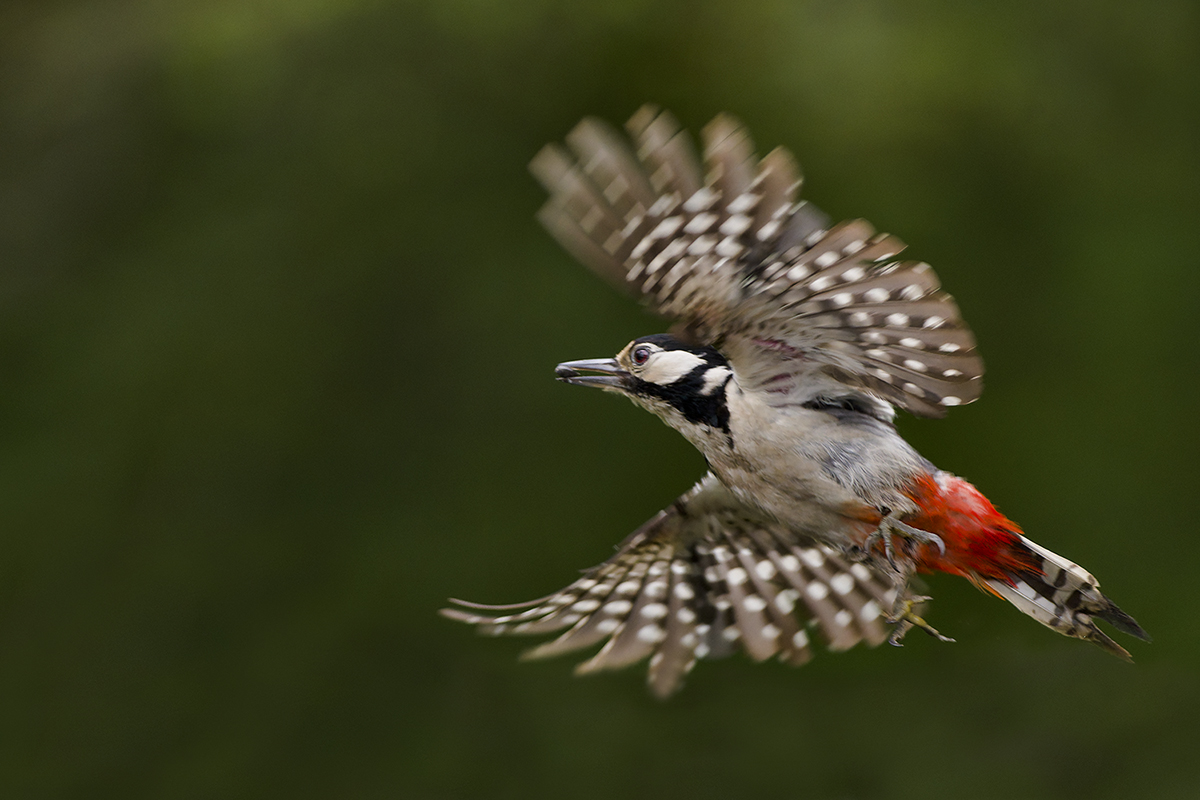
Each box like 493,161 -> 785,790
554,333 -> 733,435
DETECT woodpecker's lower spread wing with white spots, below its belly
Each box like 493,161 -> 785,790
442,475 -> 895,697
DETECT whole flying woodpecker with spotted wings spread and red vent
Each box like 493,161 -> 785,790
443,107 -> 1148,697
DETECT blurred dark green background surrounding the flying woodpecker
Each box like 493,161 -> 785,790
0,0 -> 1200,799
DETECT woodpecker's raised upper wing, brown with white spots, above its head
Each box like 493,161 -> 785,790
530,107 -> 983,416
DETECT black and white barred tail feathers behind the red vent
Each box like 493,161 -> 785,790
984,536 -> 1150,661
